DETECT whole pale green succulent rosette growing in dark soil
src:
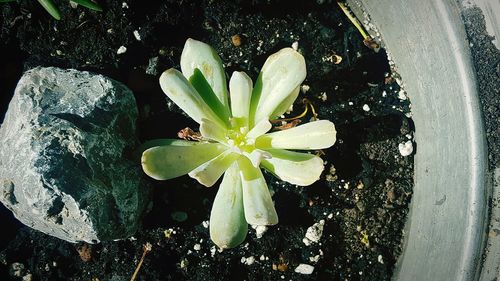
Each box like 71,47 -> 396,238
141,39 -> 336,248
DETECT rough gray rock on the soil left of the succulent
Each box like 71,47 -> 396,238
0,67 -> 149,243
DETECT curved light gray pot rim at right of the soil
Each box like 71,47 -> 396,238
350,0 -> 488,280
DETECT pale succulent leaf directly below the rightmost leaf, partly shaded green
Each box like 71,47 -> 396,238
261,149 -> 324,186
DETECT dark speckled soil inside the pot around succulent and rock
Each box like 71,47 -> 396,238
0,0 -> 414,281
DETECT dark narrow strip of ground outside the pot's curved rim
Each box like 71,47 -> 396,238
462,4 -> 500,280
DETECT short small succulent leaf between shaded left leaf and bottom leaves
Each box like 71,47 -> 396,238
189,150 -> 240,187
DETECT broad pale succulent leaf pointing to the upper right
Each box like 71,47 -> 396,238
250,48 -> 306,124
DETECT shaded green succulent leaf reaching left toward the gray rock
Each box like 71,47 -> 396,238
141,142 -> 227,180
